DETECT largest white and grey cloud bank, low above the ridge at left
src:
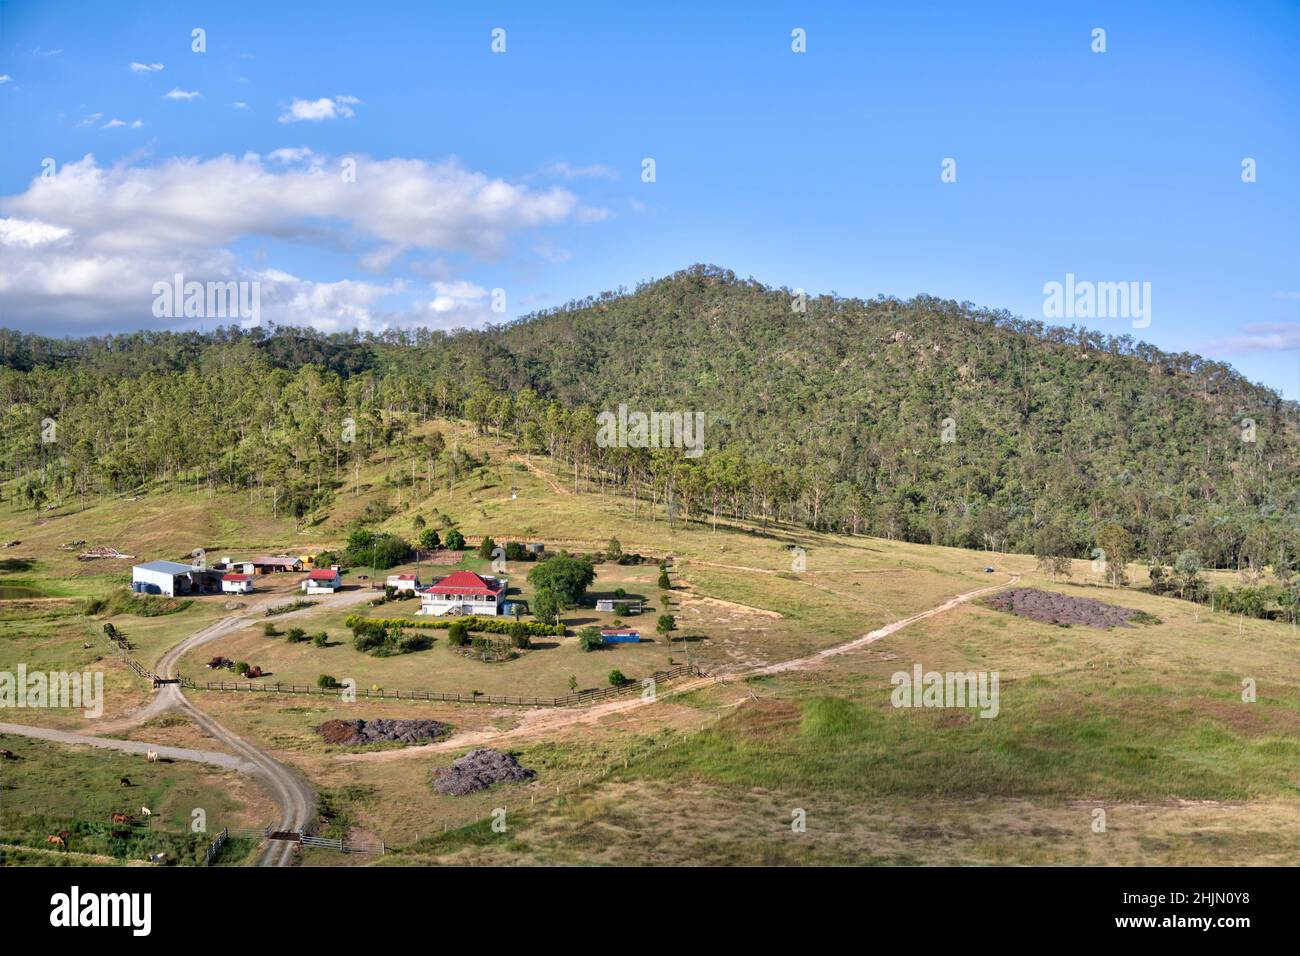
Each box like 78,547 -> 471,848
0,153 -> 605,334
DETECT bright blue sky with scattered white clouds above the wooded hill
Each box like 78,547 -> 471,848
0,0 -> 1300,398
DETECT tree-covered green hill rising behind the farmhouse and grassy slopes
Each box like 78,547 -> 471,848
0,267 -> 1300,567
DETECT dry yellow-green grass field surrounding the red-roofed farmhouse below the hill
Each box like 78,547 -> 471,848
0,424 -> 1300,865
